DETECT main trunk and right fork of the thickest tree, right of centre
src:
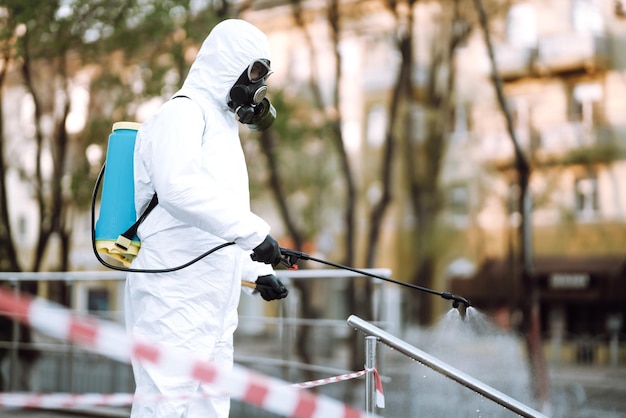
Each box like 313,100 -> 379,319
404,0 -> 460,324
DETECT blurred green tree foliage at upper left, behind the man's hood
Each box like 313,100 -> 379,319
0,0 -> 232,263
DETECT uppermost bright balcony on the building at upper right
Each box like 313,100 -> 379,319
534,32 -> 609,74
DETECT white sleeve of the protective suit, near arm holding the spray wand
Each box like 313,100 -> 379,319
146,99 -> 270,250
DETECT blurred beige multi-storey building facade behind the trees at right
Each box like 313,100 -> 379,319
244,0 -> 626,362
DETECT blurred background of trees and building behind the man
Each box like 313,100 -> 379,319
0,0 -> 626,417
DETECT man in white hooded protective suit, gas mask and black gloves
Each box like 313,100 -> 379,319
126,19 -> 288,418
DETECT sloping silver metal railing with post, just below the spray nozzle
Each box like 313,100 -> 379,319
348,315 -> 547,418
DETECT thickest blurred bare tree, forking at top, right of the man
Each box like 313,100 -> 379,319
388,0 -> 470,323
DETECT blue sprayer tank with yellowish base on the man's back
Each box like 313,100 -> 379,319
95,122 -> 141,266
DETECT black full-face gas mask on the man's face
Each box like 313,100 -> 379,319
228,59 -> 276,131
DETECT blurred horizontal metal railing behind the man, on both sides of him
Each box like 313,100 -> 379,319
0,269 -> 390,392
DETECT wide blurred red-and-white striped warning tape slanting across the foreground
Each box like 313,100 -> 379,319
0,288 -> 378,418
